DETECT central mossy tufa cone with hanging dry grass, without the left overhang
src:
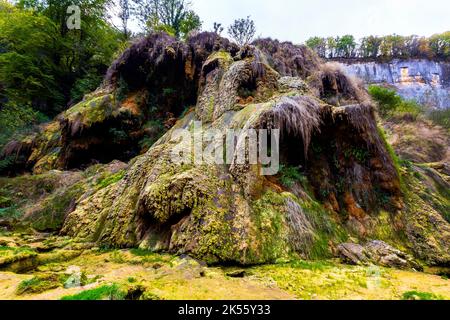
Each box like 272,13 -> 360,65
55,35 -> 400,264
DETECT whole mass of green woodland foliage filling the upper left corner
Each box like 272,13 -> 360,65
0,0 -> 120,118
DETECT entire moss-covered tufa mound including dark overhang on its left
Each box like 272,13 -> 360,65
3,33 -> 450,264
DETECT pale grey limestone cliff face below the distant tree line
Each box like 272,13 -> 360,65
342,59 -> 450,109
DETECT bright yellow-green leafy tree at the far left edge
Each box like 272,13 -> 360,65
0,1 -> 64,111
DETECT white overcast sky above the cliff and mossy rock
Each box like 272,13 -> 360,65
191,0 -> 450,43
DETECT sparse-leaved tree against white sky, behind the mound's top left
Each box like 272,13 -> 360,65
133,0 -> 202,38
